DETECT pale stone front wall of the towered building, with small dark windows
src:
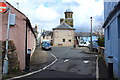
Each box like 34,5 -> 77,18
53,30 -> 74,46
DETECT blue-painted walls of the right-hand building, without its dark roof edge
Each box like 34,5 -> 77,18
104,3 -> 120,77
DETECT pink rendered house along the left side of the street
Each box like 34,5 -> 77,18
0,1 -> 36,70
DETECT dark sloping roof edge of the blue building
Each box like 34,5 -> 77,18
102,1 -> 120,28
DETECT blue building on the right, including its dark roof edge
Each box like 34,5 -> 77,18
103,1 -> 120,78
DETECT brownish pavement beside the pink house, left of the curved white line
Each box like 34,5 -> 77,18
30,47 -> 54,71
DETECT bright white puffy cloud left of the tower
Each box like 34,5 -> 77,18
33,5 -> 59,22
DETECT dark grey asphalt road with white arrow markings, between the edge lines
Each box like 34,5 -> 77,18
12,47 -> 97,79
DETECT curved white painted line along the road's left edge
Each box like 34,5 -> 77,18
6,53 -> 58,80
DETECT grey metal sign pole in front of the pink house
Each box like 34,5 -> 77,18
3,8 -> 11,75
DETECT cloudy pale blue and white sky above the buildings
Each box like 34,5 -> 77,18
6,0 -> 104,35
